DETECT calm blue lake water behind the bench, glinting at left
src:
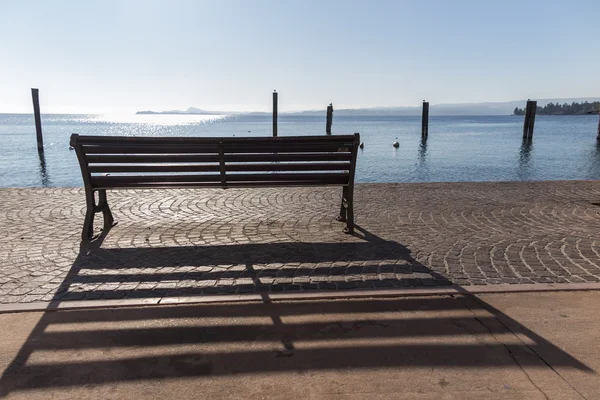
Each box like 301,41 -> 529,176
0,114 -> 600,187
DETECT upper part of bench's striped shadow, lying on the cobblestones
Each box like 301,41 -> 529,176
54,226 -> 451,301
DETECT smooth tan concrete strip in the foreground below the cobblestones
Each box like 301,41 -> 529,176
0,291 -> 600,400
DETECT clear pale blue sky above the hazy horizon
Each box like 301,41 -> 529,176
0,0 -> 600,112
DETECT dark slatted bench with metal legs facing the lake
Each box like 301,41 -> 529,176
71,133 -> 360,240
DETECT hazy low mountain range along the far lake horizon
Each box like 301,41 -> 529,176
136,97 -> 600,116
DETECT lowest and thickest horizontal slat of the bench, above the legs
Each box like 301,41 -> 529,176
91,172 -> 349,187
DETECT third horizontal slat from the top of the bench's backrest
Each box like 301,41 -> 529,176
86,153 -> 352,164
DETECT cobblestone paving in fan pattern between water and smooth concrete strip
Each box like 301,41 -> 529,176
0,181 -> 600,303
